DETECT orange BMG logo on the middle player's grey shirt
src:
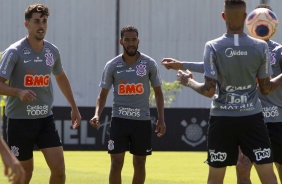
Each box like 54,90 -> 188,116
118,83 -> 144,95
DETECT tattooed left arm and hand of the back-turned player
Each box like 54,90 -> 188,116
177,70 -> 216,98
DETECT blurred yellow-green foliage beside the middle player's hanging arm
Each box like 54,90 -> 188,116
149,81 -> 182,107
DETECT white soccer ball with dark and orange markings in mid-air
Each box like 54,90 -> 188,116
246,8 -> 278,40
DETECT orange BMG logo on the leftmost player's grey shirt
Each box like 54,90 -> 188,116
24,74 -> 50,87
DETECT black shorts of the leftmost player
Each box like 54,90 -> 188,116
5,115 -> 62,161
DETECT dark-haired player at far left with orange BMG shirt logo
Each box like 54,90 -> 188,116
0,4 -> 81,184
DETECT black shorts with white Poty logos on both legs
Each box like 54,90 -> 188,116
207,113 -> 273,168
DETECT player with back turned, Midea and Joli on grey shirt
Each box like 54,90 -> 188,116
172,0 -> 282,184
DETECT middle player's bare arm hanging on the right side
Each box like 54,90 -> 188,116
154,86 -> 166,137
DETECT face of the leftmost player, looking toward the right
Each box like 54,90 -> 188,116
25,13 -> 48,40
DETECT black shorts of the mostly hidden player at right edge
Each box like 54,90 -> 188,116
266,122 -> 282,164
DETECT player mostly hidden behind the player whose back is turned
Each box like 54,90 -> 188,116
162,4 -> 282,184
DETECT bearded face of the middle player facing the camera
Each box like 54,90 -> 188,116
120,31 -> 139,56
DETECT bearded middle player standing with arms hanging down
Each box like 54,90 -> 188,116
90,25 -> 166,184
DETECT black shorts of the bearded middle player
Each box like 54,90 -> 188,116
108,117 -> 152,156
